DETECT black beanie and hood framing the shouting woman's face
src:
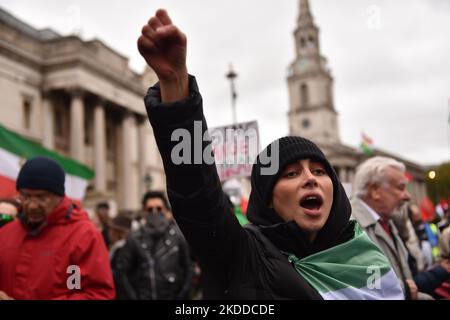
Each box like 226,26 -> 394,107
247,137 -> 353,258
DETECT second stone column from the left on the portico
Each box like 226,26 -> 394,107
94,99 -> 106,193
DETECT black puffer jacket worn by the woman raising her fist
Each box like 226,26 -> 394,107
145,77 -> 352,299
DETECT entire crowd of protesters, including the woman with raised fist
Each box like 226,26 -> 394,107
0,10 -> 450,300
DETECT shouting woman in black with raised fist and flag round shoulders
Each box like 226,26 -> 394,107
138,9 -> 404,300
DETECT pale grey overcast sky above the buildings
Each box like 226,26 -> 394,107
0,0 -> 450,164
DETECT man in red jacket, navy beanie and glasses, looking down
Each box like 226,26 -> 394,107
0,157 -> 115,300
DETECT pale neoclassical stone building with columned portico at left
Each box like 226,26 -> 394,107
0,8 -> 165,209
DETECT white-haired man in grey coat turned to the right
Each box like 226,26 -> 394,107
351,157 -> 418,300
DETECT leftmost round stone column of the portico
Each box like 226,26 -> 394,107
70,90 -> 84,162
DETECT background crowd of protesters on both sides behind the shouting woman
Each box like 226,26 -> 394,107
0,157 -> 450,300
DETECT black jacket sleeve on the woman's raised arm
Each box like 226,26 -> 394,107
145,76 -> 246,296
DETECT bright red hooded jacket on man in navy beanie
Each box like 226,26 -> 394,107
0,197 -> 115,300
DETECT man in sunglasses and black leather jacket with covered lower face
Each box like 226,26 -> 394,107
116,191 -> 193,300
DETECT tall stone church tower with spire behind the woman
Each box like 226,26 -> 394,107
288,0 -> 340,146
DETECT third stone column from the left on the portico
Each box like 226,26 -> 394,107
119,112 -> 136,209
